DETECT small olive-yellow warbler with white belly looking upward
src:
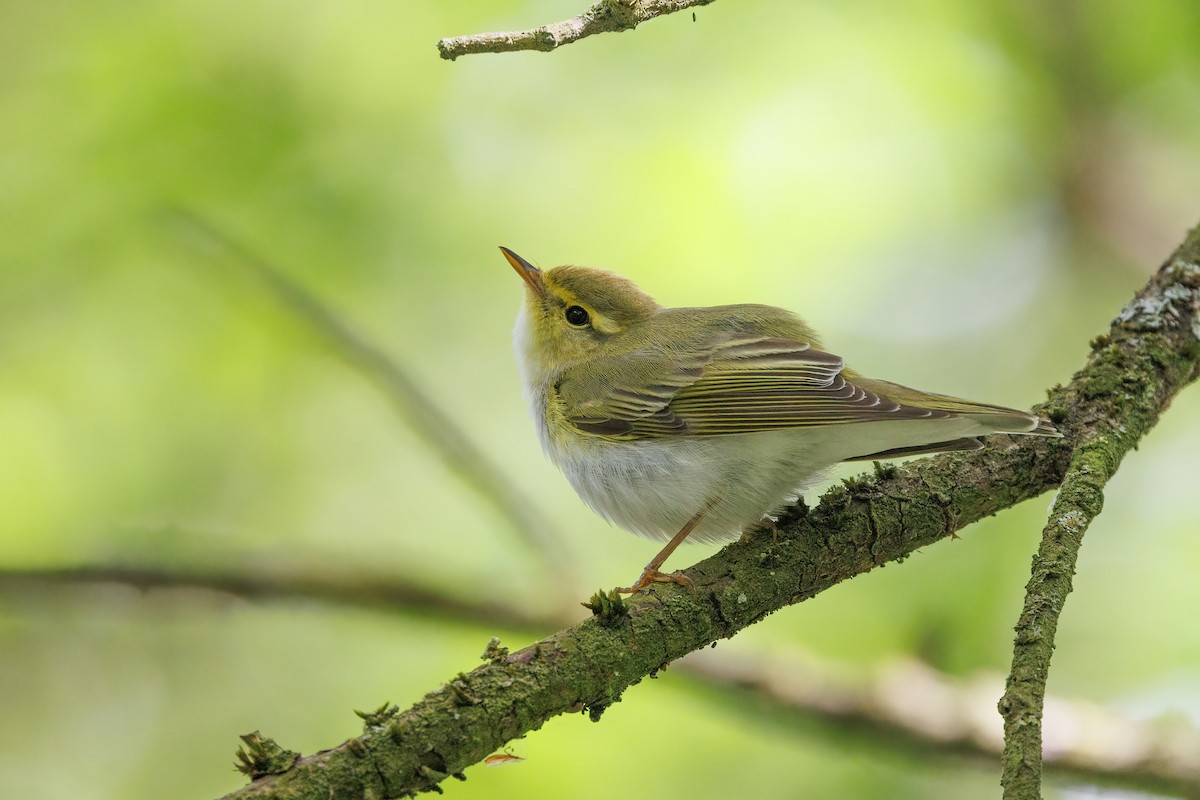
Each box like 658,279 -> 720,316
500,247 -> 1060,593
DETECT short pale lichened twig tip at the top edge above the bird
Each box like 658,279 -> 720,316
438,0 -> 713,61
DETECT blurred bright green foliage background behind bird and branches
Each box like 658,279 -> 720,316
0,0 -> 1200,800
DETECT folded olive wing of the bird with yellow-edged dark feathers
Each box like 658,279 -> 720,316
559,337 -> 969,440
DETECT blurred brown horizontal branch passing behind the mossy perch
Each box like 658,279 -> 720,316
9,557 -> 1200,796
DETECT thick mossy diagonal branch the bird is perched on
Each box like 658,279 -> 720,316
213,228 -> 1200,800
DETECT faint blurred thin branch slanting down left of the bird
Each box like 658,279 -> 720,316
169,209 -> 569,573
